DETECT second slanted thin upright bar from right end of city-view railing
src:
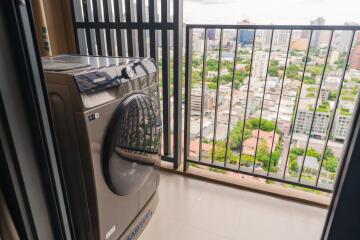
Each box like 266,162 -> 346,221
298,30 -> 334,182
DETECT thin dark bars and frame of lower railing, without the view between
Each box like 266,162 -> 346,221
183,24 -> 360,192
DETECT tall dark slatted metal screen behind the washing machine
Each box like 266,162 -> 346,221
73,0 -> 182,167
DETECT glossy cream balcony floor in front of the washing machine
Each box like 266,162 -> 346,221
139,172 -> 327,240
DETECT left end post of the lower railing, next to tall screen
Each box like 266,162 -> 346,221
183,27 -> 193,172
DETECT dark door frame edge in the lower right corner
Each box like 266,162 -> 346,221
322,92 -> 360,240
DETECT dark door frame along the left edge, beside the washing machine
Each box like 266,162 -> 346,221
0,0 -> 72,239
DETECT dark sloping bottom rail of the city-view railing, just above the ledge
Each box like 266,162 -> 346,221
186,159 -> 332,193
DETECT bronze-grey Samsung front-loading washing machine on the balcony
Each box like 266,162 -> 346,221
42,55 -> 161,240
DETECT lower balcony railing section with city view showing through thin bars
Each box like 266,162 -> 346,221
184,25 -> 360,192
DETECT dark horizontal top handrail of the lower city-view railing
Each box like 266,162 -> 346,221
186,24 -> 360,31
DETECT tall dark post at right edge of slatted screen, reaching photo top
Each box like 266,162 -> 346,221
173,0 -> 183,168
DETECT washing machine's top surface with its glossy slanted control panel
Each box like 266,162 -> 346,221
42,55 -> 157,93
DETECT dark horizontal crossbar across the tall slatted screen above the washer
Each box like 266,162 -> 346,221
75,22 -> 176,30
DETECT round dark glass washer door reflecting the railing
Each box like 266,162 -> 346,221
102,94 -> 161,196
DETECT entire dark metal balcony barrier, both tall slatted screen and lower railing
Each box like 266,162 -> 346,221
72,0 -> 360,192
